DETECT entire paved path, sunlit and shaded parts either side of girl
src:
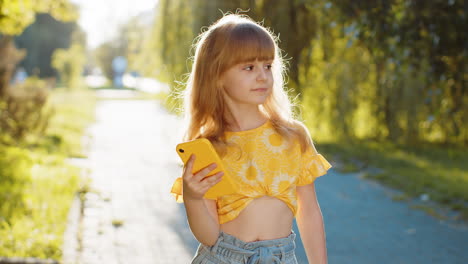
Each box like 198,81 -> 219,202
74,95 -> 468,264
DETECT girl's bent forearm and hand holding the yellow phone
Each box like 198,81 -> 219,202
182,155 -> 223,246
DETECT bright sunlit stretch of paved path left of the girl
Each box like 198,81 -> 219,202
77,100 -> 195,264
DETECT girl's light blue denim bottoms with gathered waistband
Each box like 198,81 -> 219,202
192,231 -> 297,264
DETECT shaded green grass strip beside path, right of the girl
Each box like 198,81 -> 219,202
317,140 -> 468,220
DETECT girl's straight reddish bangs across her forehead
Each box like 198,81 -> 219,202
223,23 -> 275,69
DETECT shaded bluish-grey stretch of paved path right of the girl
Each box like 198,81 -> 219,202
316,171 -> 468,264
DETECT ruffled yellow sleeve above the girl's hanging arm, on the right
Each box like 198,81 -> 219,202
296,148 -> 332,186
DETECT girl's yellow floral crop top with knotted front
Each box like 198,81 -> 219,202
171,121 -> 331,224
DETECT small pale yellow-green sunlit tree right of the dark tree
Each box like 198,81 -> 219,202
52,44 -> 86,89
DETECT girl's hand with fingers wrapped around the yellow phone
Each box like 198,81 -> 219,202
182,154 -> 224,200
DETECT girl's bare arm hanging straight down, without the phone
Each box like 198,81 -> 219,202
296,183 -> 327,264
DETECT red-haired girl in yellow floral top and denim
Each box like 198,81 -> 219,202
172,14 -> 331,264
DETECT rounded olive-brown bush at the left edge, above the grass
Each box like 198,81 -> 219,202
0,78 -> 53,145
